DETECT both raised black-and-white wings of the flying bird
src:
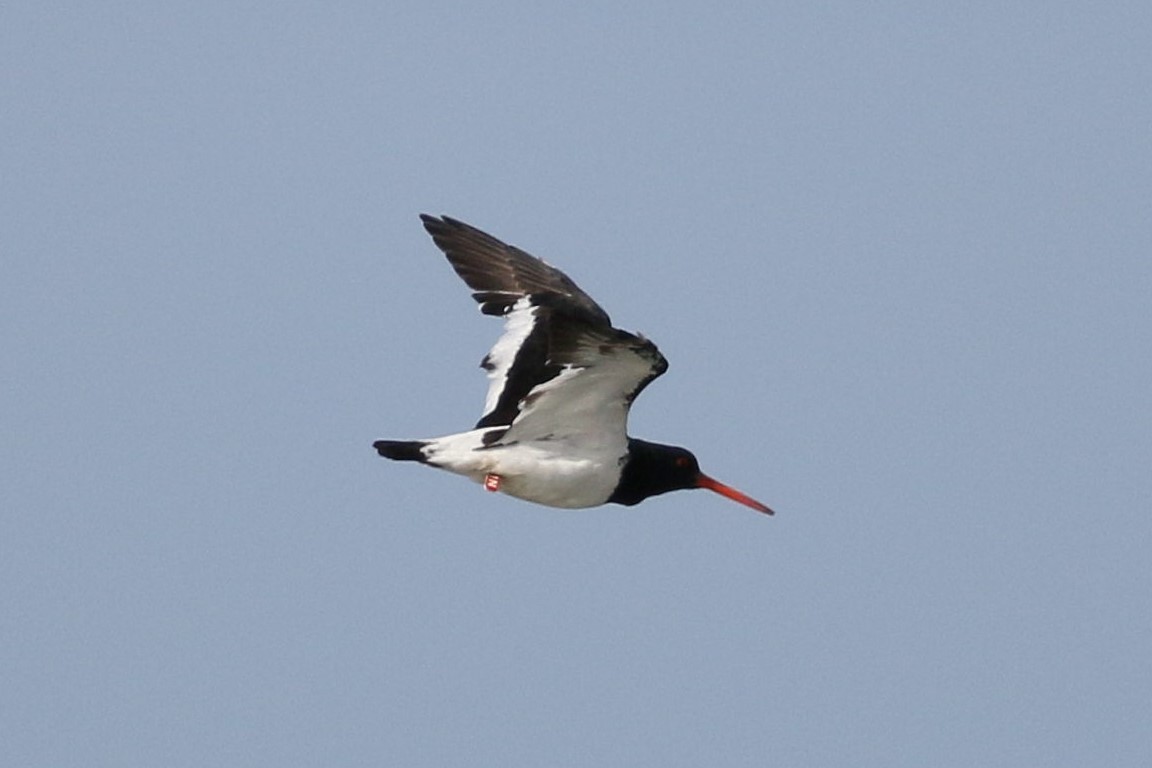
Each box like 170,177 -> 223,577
420,214 -> 667,433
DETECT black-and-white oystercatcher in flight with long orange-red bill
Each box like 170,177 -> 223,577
373,213 -> 774,515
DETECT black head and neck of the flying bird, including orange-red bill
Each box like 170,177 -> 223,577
608,438 -> 772,515
